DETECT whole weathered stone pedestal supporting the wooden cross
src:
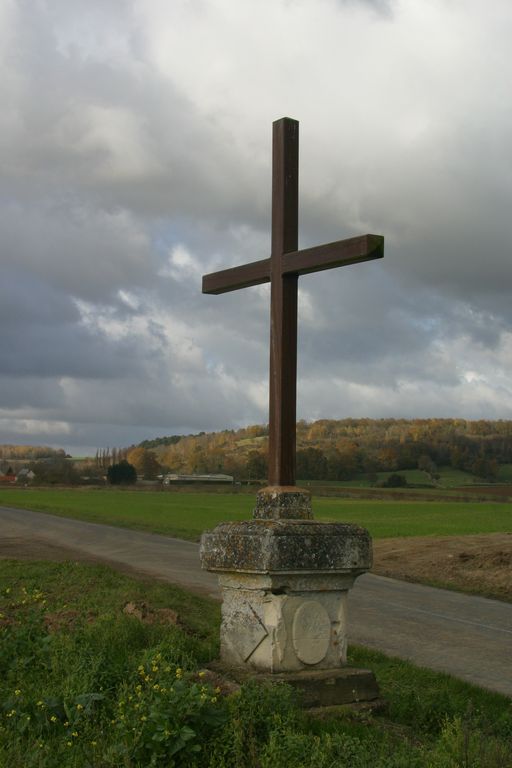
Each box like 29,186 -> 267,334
200,488 -> 378,703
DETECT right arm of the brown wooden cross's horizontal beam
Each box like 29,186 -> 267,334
283,235 -> 384,275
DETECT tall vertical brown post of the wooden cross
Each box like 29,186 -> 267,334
268,118 -> 299,486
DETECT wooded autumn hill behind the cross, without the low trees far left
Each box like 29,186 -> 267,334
140,419 -> 512,482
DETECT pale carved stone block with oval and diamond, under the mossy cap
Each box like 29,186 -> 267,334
219,573 -> 353,673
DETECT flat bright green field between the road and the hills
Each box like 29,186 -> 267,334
0,489 -> 512,540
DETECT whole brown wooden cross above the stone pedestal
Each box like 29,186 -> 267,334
203,117 -> 384,486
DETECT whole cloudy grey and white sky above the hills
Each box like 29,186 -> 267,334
0,0 -> 512,453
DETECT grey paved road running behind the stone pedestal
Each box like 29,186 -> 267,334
0,507 -> 512,697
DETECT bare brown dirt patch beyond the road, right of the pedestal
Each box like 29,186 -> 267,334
373,533 -> 512,602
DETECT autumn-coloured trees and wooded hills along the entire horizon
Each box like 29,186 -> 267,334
4,419 -> 512,483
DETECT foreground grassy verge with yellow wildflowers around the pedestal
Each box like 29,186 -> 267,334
0,561 -> 512,768
